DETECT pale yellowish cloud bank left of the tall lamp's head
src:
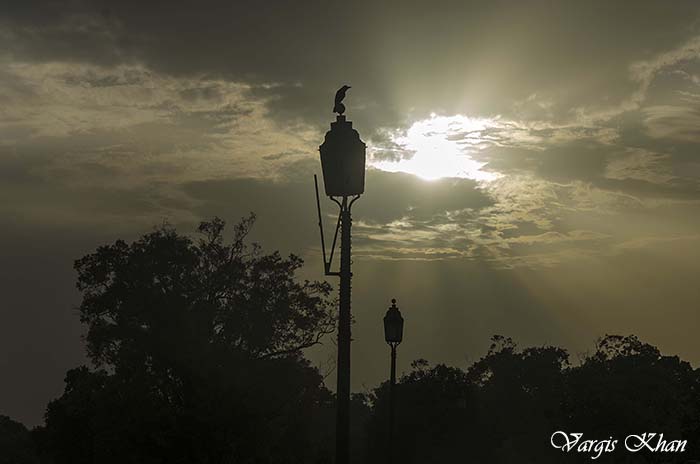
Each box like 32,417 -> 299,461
0,63 -> 326,180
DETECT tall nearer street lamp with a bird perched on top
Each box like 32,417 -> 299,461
314,86 -> 366,464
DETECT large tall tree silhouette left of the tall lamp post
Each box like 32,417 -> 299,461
42,216 -> 334,464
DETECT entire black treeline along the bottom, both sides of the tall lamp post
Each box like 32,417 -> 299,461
0,216 -> 700,464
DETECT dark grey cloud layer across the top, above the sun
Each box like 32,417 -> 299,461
2,0 -> 698,130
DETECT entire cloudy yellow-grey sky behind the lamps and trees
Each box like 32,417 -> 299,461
0,0 -> 700,425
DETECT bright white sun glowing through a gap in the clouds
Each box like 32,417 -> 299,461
370,114 -> 500,182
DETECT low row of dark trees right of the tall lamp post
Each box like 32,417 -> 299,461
367,335 -> 700,464
